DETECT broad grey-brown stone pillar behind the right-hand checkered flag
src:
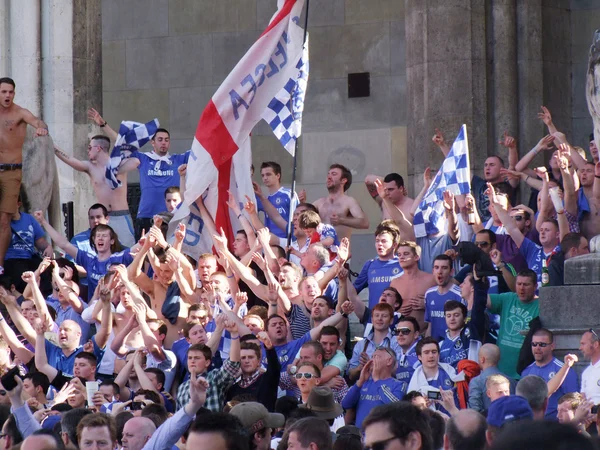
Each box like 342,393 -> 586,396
406,0 -> 488,193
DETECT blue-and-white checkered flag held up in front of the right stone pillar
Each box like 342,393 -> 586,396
413,125 -> 471,238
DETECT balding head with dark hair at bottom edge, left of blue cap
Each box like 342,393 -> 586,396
444,409 -> 487,450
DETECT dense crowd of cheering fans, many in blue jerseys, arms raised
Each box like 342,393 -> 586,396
0,75 -> 600,450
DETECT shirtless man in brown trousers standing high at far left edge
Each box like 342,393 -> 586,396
0,78 -> 48,274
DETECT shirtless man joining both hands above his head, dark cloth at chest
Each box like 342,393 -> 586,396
127,226 -> 196,349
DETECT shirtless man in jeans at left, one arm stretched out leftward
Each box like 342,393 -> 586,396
54,128 -> 139,247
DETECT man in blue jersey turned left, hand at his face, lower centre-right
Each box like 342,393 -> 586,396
342,347 -> 406,428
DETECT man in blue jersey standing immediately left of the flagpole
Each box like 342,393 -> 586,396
255,161 -> 299,246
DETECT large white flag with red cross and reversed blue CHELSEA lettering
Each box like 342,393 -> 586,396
169,0 -> 304,258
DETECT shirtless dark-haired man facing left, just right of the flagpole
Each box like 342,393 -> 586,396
314,164 -> 369,241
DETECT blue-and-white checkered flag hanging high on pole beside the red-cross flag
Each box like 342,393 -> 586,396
262,37 -> 309,156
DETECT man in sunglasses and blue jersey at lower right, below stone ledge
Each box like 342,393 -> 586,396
521,328 -> 579,420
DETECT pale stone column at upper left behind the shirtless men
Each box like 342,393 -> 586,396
0,0 -> 102,231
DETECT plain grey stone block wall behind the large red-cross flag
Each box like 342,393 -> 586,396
102,0 -> 407,270
